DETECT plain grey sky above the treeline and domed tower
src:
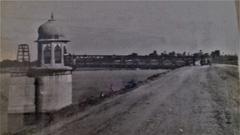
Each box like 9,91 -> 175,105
0,0 -> 239,60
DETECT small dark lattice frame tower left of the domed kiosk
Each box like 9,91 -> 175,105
17,44 -> 30,63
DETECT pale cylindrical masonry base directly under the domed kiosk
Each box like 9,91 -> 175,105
37,74 -> 72,112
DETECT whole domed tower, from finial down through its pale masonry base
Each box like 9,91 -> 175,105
28,14 -> 72,113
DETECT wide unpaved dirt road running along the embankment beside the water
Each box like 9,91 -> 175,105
35,65 -> 240,135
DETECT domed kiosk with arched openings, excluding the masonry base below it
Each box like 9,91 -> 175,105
36,13 -> 70,68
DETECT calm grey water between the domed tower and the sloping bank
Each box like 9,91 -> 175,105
73,69 -> 166,103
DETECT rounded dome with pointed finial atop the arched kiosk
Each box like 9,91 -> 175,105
38,14 -> 64,39
